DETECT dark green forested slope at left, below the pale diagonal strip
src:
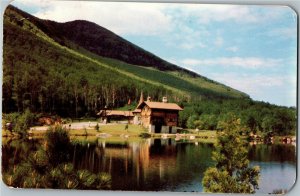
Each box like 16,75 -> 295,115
3,12 -> 171,116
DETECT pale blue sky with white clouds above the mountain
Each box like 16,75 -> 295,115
12,0 -> 297,106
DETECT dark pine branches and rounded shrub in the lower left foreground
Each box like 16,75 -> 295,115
3,127 -> 111,189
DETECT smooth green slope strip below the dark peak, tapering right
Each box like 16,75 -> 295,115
89,54 -> 247,99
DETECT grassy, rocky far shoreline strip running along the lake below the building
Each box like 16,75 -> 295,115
2,121 -> 296,144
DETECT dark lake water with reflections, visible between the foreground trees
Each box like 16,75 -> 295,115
2,139 -> 296,193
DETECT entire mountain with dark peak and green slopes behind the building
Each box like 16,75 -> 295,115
2,6 -> 249,116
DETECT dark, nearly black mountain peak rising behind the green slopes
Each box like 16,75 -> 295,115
5,7 -> 197,77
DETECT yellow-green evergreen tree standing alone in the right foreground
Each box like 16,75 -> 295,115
202,115 -> 260,193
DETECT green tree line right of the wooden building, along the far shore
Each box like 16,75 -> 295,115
179,99 -> 296,135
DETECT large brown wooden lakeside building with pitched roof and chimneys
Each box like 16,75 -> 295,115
137,97 -> 183,133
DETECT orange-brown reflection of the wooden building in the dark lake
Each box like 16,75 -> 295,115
74,139 -> 177,190
